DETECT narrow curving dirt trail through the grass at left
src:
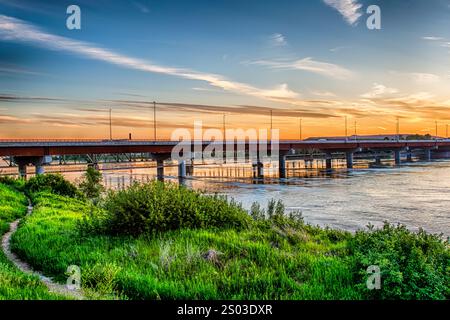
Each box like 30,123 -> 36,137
2,204 -> 84,300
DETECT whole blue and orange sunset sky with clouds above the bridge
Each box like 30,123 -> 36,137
0,0 -> 450,139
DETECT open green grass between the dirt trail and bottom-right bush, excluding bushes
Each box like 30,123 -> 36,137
13,194 -> 361,299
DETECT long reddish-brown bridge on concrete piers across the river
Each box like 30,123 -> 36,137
0,139 -> 450,178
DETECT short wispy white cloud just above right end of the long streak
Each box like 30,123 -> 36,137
250,57 -> 354,80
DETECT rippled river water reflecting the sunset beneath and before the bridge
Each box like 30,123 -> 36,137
5,161 -> 450,236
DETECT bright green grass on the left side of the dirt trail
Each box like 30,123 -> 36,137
0,184 -> 58,300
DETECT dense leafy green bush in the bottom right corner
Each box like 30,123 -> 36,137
349,223 -> 450,300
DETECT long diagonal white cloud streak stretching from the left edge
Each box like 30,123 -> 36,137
0,15 -> 300,100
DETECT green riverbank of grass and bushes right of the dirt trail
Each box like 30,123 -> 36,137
0,174 -> 450,300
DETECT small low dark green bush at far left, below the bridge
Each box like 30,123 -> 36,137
25,174 -> 79,198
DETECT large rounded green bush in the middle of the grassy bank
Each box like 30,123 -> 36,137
81,181 -> 251,236
